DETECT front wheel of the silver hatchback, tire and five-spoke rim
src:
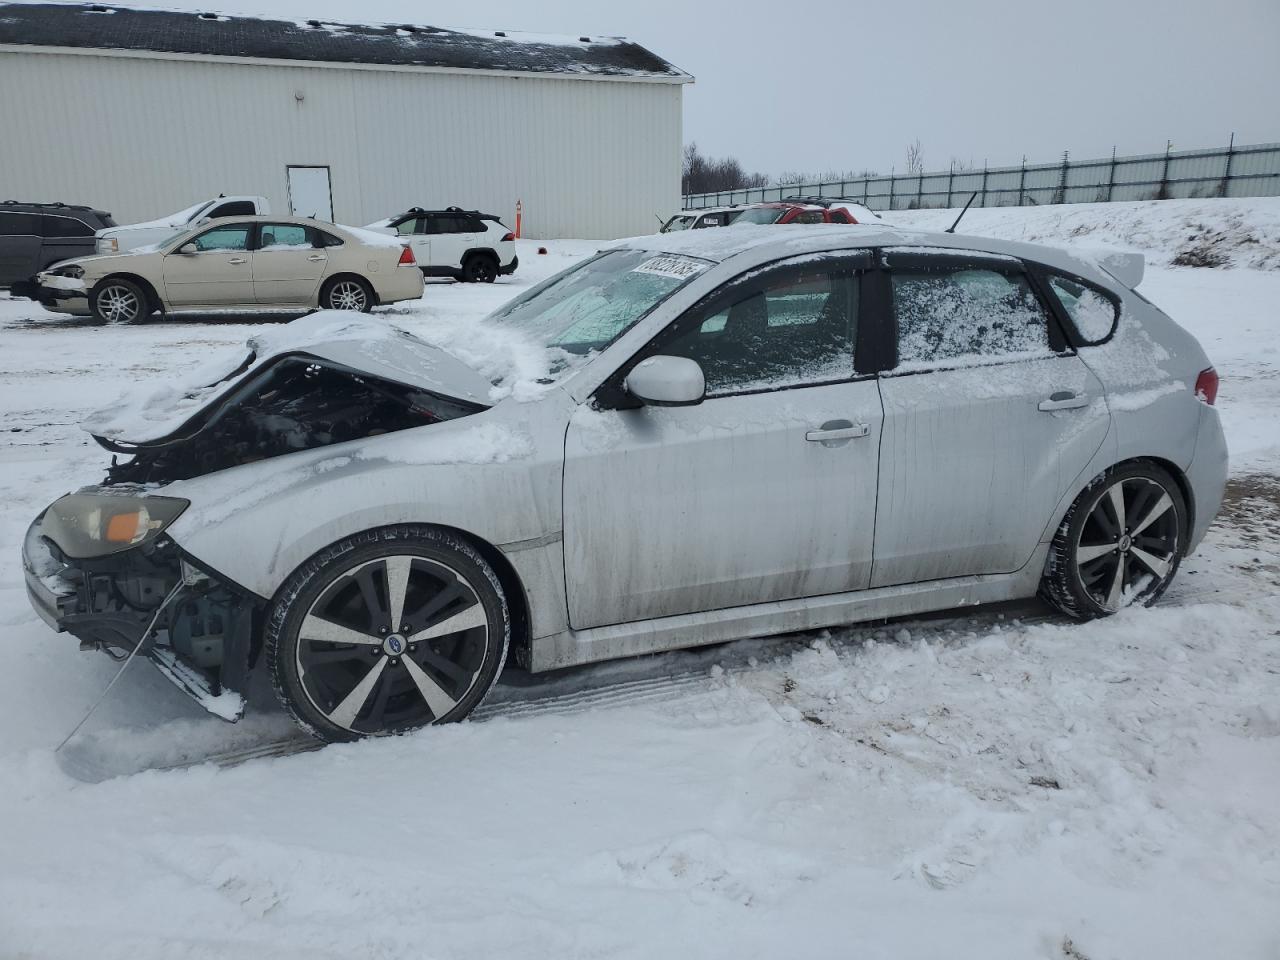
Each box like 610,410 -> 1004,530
265,526 -> 511,742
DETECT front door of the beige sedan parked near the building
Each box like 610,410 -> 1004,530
163,223 -> 253,307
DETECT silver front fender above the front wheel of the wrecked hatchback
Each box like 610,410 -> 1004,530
164,403 -> 563,598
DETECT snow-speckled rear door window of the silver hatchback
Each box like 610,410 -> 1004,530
892,265 -> 1056,371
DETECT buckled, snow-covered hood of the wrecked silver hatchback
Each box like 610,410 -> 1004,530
82,310 -> 490,444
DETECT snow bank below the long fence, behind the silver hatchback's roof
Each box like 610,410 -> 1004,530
884,197 -> 1280,270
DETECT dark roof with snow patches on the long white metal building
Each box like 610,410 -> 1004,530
0,3 -> 692,83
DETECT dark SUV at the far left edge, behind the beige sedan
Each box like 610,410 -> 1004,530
0,200 -> 115,297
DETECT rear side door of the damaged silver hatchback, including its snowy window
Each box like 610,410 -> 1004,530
872,251 -> 1110,586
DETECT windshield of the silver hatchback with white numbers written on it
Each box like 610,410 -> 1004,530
489,250 -> 712,355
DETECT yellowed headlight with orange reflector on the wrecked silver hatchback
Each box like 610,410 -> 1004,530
41,493 -> 191,559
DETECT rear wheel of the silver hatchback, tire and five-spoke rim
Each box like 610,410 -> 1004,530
1039,461 -> 1189,620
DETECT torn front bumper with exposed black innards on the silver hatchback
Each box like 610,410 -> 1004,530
22,513 -> 265,721
